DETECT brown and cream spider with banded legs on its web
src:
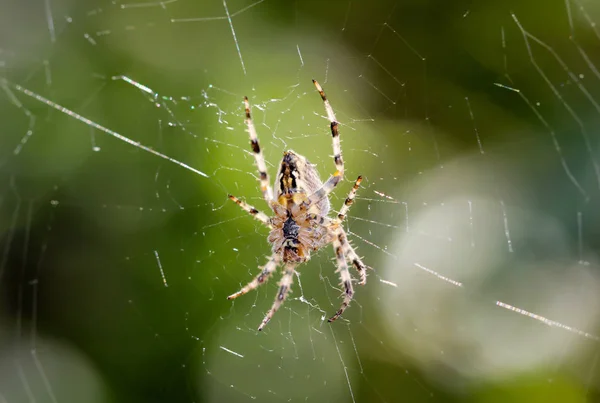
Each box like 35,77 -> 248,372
227,80 -> 367,331
